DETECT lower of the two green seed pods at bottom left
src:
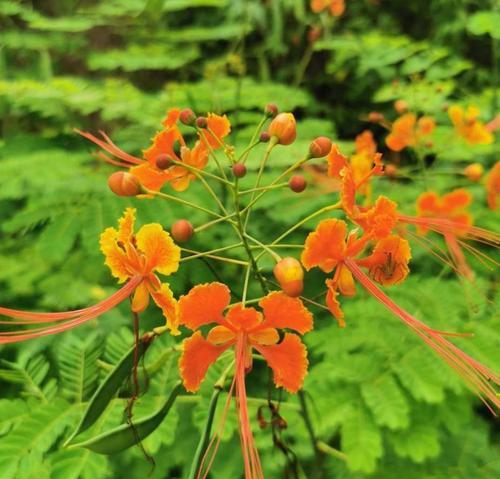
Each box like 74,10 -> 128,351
70,382 -> 182,454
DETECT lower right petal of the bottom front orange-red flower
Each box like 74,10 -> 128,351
254,333 -> 308,393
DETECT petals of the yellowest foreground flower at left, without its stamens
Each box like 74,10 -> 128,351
100,208 -> 181,334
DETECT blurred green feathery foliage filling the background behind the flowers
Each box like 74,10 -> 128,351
0,0 -> 500,479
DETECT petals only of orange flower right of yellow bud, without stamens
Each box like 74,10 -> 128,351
301,219 -> 411,327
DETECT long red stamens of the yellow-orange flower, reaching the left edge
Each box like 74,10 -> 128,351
0,276 -> 143,344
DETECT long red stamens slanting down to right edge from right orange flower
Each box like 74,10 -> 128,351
345,259 -> 500,415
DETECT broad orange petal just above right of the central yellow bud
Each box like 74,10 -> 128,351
301,219 -> 347,273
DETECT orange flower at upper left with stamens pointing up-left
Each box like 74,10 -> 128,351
76,108 -> 231,191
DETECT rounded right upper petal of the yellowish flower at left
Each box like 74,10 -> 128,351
136,223 -> 181,275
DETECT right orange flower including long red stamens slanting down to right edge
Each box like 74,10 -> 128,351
302,219 -> 500,412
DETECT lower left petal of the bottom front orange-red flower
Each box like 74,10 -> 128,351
179,331 -> 229,392
